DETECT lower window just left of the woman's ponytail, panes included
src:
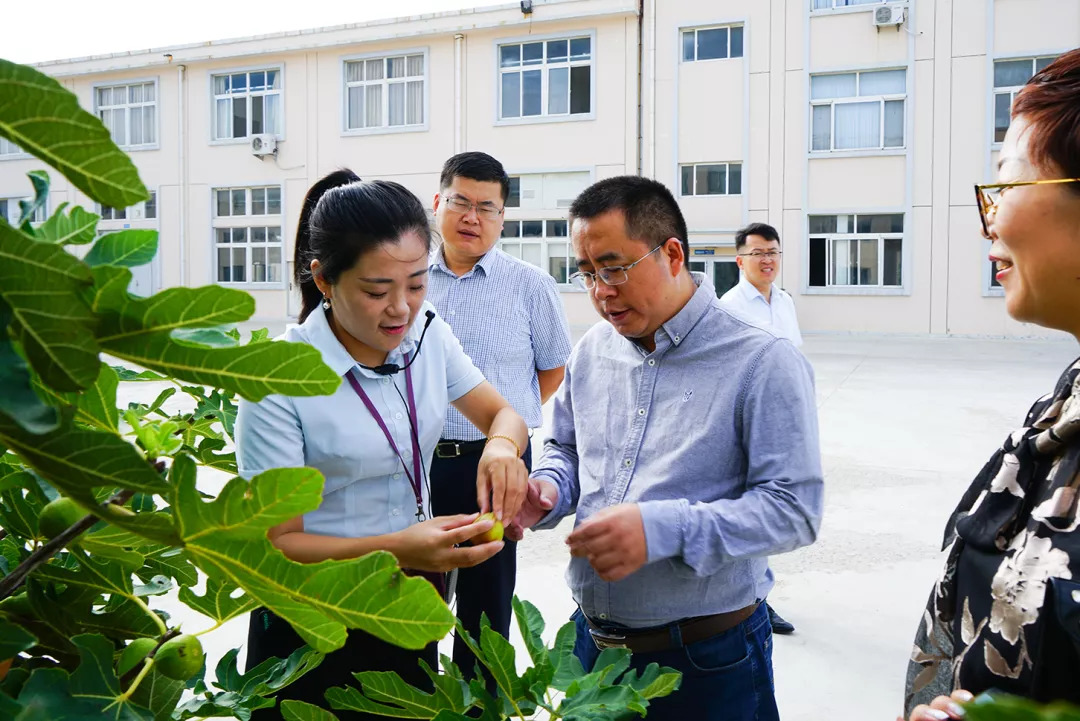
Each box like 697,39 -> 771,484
213,186 -> 285,284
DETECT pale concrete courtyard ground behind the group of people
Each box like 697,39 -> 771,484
141,329 -> 1080,721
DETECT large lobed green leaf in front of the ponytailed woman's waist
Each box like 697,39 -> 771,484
172,455 -> 454,652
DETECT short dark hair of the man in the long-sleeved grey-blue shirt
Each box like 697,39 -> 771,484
570,175 -> 690,262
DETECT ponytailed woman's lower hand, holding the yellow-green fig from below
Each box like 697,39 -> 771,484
384,514 -> 504,573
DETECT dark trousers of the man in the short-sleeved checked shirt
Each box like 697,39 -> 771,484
431,443 -> 532,678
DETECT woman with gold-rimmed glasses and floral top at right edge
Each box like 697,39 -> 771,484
905,50 -> 1080,721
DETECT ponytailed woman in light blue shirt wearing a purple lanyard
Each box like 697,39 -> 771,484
237,171 -> 528,719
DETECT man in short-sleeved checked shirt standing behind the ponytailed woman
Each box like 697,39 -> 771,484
428,152 -> 570,675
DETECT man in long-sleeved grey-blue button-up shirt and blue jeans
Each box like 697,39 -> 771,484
513,176 -> 823,720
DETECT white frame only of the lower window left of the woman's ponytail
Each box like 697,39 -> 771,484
208,182 -> 288,290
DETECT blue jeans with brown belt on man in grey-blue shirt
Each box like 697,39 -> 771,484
571,601 -> 780,721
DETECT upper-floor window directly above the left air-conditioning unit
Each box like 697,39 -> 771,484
214,68 -> 282,140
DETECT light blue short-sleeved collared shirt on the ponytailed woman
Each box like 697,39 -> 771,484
235,301 -> 484,538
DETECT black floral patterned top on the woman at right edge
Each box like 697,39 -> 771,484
904,359 -> 1080,716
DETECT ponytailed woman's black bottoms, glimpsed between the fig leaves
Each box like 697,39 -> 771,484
245,609 -> 438,721
